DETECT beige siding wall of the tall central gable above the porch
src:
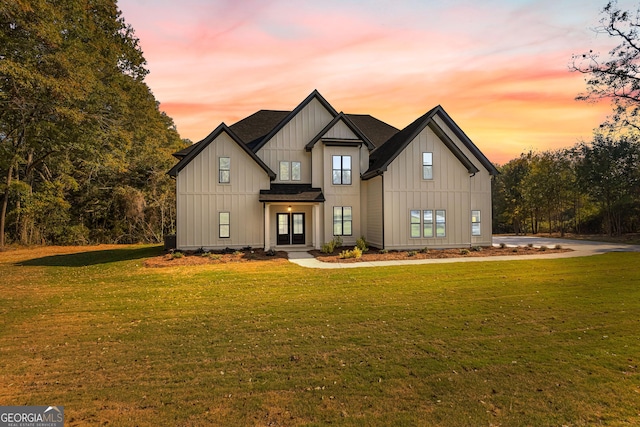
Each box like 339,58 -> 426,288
256,99 -> 333,184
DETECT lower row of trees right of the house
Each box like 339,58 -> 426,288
493,134 -> 640,236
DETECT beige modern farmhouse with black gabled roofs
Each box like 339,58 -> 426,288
169,91 -> 497,250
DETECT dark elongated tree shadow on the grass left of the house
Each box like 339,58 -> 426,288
17,246 -> 163,267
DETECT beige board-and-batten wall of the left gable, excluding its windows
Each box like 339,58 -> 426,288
176,133 -> 270,250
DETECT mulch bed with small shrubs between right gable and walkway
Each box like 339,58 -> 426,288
309,246 -> 573,262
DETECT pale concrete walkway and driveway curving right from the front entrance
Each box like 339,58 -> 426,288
288,236 -> 640,269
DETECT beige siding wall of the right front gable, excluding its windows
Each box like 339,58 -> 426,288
384,124 -> 491,249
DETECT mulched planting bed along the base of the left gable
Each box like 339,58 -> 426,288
144,249 -> 288,267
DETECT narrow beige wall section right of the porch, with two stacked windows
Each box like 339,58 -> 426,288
322,143 -> 363,246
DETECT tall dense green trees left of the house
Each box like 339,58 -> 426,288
0,0 -> 186,248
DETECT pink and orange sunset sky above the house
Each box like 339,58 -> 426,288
118,0 -> 634,164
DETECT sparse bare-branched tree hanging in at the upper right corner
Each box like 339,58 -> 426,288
569,1 -> 640,130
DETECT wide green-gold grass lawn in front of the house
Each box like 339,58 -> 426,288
0,246 -> 640,426
